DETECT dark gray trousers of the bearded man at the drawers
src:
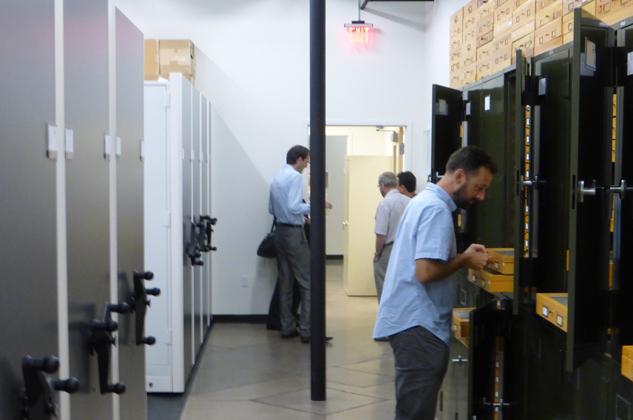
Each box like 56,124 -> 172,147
389,327 -> 449,420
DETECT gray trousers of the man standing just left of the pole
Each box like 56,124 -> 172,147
275,225 -> 310,337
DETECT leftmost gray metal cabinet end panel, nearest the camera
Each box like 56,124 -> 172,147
0,0 -> 58,420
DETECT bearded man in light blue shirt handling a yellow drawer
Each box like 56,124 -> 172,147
374,146 -> 496,420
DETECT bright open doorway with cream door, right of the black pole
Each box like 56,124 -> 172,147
325,125 -> 406,296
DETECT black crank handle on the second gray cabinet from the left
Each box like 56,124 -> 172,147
88,302 -> 130,394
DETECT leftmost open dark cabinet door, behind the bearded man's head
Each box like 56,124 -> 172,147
429,85 -> 464,183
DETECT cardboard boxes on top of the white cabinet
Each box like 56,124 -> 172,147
145,39 -> 195,81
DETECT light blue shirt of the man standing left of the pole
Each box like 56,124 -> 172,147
268,164 -> 310,225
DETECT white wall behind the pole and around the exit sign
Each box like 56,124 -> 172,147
118,0 -> 465,314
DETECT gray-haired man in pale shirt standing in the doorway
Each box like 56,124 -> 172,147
374,172 -> 409,302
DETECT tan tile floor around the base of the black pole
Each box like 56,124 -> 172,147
181,261 -> 395,420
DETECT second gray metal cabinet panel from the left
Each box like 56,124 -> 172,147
64,0 -> 112,420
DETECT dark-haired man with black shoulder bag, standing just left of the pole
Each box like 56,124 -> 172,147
268,145 -> 332,343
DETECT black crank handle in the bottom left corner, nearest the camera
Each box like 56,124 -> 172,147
22,355 -> 79,419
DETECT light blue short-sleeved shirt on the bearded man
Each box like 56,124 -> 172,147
374,183 -> 457,343
